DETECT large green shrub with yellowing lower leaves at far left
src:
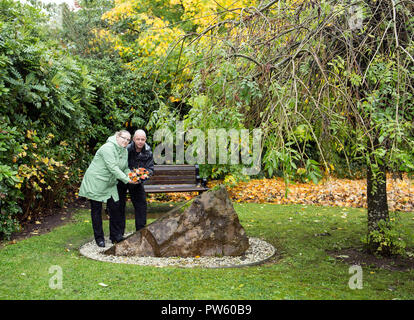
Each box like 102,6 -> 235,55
0,0 -> 94,229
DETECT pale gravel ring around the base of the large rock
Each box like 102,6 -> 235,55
79,238 -> 276,268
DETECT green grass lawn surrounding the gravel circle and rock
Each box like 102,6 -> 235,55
0,203 -> 414,300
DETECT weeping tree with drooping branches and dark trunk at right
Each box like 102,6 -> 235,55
161,0 -> 414,254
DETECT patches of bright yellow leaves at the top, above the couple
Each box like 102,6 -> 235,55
100,0 -> 260,95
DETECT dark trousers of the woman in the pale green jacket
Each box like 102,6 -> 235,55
90,197 -> 125,243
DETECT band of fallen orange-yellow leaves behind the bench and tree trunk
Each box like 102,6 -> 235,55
149,175 -> 414,212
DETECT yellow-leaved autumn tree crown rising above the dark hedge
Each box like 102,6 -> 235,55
102,0 -> 255,91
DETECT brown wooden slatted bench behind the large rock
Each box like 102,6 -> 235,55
144,164 -> 208,194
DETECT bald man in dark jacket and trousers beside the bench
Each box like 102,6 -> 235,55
118,130 -> 154,233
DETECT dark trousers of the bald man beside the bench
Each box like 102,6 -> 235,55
118,182 -> 147,234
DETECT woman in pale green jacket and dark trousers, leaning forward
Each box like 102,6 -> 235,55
79,130 -> 133,247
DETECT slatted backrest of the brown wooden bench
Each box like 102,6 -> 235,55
145,164 -> 198,185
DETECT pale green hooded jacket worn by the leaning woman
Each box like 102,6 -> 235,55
79,135 -> 130,202
